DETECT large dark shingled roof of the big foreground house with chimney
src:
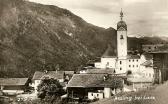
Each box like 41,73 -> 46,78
67,74 -> 123,88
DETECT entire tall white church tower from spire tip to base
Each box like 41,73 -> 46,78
116,10 -> 127,74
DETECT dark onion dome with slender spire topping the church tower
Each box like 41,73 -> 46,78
117,10 -> 127,30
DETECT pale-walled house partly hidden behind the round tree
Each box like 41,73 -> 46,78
31,70 -> 74,93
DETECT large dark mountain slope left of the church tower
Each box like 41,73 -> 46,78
0,0 -> 116,77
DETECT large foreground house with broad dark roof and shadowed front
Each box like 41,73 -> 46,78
67,74 -> 124,100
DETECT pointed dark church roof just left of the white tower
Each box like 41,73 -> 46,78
102,45 -> 117,58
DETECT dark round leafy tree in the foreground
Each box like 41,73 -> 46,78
38,78 -> 64,102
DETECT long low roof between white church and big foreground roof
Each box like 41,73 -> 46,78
86,68 -> 115,74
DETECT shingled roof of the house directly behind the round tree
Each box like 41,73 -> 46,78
33,71 -> 64,80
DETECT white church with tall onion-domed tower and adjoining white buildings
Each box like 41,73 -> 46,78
94,10 -> 152,75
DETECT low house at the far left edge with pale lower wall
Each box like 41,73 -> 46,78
0,78 -> 29,95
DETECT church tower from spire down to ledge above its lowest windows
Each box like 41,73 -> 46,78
117,10 -> 127,59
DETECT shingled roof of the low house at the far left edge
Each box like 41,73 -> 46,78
0,78 -> 28,86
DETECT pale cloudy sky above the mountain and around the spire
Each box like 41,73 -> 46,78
29,0 -> 168,37
